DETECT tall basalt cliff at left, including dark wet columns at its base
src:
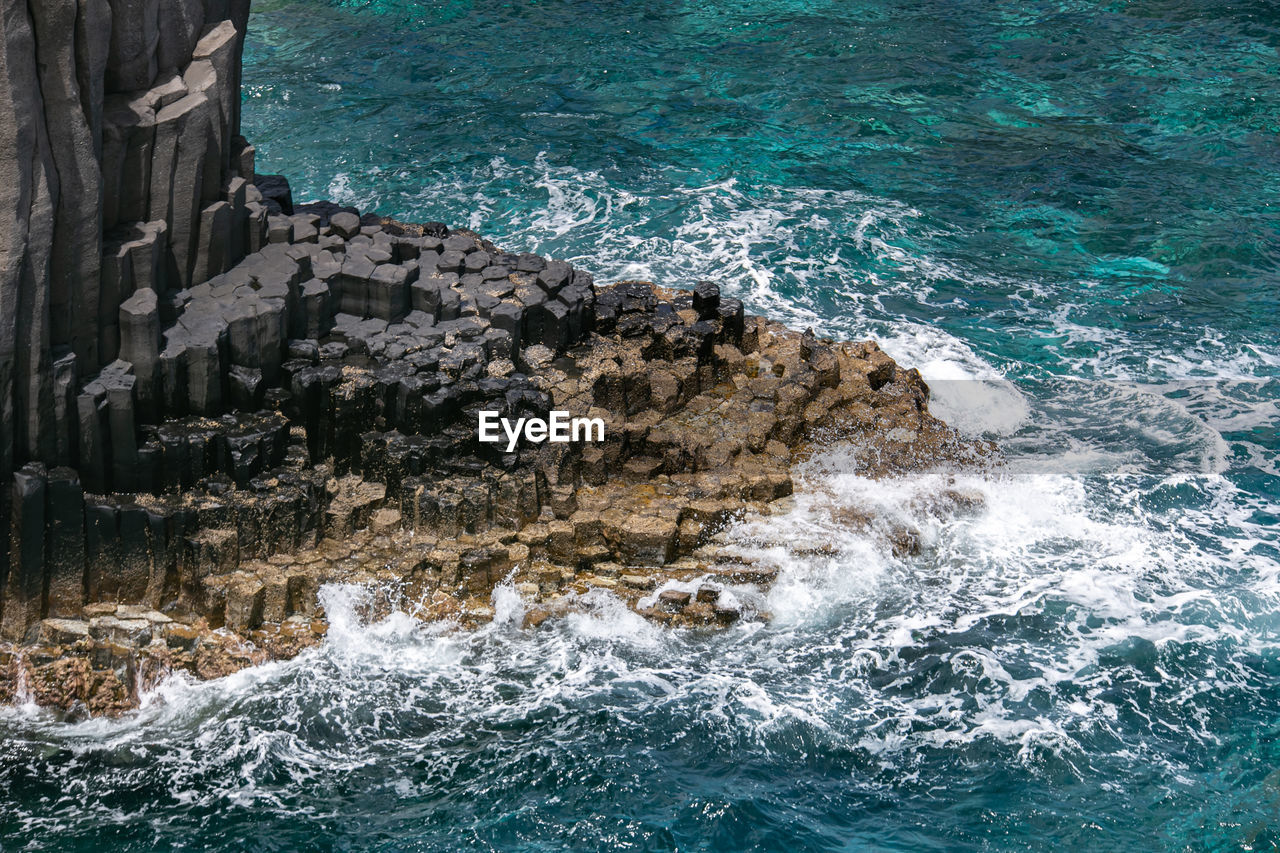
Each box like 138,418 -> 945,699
0,0 -> 259,638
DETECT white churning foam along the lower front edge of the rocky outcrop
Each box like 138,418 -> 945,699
7,425 -> 1277,788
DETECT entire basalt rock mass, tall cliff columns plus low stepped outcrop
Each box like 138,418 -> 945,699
0,0 -> 989,713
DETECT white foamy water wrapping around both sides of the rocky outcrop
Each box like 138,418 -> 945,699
4,167 -> 1280,829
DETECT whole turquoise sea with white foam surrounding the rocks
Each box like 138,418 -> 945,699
0,0 -> 1280,850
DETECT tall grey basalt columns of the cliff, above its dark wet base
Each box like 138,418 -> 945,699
0,0 -> 254,476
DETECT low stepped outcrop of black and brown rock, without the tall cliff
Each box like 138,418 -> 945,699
0,212 -> 984,712
